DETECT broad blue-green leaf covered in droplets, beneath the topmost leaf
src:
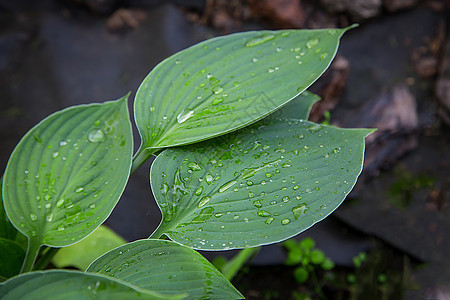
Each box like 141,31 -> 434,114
150,119 -> 372,250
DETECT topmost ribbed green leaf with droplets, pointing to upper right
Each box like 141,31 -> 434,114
134,28 -> 349,153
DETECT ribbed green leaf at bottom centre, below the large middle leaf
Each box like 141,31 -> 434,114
87,240 -> 243,299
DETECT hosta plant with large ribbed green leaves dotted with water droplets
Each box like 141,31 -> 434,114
0,28 -> 371,299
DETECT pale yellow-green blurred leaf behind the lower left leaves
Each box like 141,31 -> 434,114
52,225 -> 126,270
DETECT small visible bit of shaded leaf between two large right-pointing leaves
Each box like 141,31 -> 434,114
267,91 -> 320,120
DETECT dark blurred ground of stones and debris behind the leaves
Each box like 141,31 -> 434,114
0,0 -> 450,299
